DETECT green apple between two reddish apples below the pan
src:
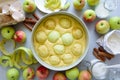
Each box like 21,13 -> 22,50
65,67 -> 79,80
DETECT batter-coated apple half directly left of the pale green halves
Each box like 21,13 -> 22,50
35,31 -> 47,43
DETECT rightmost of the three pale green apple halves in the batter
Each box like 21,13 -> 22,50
62,33 -> 73,46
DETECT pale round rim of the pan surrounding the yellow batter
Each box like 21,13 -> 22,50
31,12 -> 89,71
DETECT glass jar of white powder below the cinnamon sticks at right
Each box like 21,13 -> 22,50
88,59 -> 108,80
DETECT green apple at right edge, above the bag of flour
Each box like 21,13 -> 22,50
109,16 -> 120,29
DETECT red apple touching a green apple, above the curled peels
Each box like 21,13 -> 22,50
14,30 -> 26,42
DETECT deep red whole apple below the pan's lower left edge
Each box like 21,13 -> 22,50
36,66 -> 49,79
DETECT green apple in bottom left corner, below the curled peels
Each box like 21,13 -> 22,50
6,68 -> 19,80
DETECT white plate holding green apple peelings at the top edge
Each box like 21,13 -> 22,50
34,0 -> 67,13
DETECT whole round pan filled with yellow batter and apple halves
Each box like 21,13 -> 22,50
31,12 -> 89,71
